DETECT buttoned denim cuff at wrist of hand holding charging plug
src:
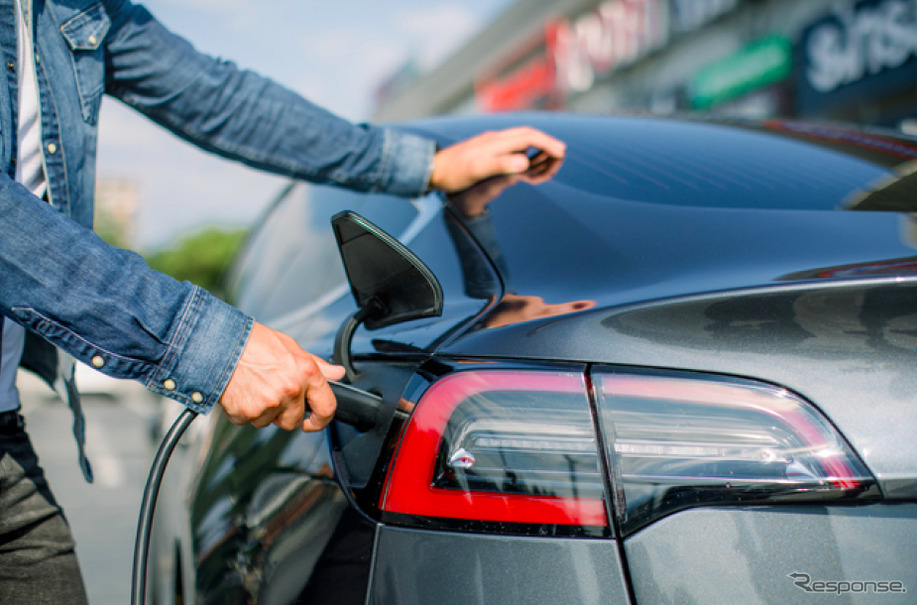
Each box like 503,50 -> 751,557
147,286 -> 253,413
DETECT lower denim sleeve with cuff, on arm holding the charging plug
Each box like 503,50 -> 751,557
0,174 -> 252,412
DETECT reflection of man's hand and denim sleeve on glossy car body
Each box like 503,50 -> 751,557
446,154 -> 595,328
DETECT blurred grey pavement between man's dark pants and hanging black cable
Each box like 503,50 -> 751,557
19,374 -> 161,605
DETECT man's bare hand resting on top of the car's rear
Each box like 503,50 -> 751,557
430,127 -> 567,193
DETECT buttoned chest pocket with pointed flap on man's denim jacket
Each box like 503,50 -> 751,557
60,2 -> 111,124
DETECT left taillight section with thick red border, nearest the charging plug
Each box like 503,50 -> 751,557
381,370 -> 608,534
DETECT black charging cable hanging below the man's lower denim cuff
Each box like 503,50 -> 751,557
131,408 -> 197,605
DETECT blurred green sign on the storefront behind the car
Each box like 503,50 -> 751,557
689,35 -> 793,109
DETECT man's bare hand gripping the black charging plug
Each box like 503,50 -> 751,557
220,322 -> 344,431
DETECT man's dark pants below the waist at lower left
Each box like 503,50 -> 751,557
0,412 -> 87,605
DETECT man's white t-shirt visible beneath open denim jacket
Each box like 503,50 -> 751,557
0,0 -> 48,412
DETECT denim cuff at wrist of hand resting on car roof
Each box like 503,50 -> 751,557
376,129 -> 436,197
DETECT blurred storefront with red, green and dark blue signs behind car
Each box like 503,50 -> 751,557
374,0 -> 917,132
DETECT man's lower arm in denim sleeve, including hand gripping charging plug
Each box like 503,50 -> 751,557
0,175 -> 343,430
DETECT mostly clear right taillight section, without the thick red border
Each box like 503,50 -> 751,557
593,371 -> 875,533
